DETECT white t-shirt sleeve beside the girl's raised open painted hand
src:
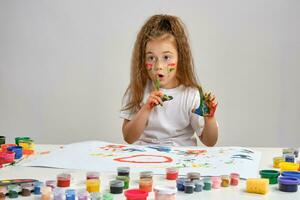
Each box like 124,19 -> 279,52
189,89 -> 204,136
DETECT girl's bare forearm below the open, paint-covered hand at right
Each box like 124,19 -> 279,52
200,117 -> 218,146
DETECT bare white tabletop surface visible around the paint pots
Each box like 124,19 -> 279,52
0,145 -> 300,200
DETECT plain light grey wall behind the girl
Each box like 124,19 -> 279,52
0,0 -> 300,147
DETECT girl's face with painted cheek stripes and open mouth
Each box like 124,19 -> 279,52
145,36 -> 178,89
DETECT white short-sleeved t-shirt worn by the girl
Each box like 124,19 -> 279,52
120,82 -> 204,146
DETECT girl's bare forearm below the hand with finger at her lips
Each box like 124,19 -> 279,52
122,105 -> 151,144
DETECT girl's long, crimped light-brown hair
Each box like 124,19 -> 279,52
122,15 -> 202,113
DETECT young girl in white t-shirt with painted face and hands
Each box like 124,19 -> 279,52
120,15 -> 218,146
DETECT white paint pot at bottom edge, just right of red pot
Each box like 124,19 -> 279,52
154,186 -> 177,200
